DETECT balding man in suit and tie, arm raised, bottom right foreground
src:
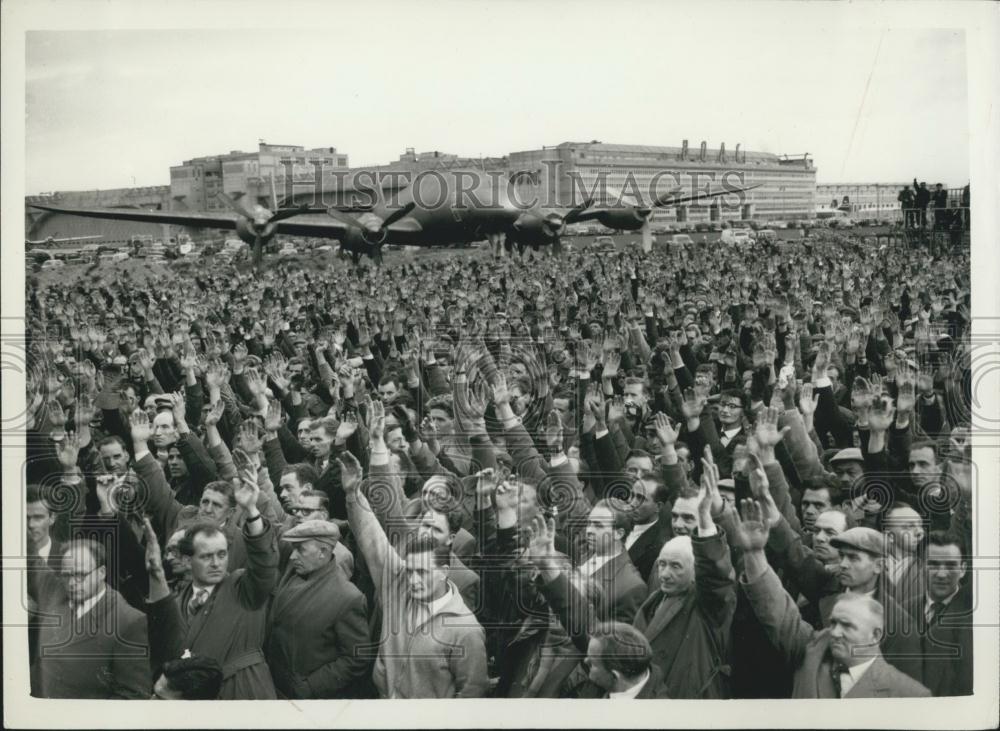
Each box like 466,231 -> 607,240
733,505 -> 930,698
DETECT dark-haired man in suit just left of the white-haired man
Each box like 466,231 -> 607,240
578,500 -> 646,622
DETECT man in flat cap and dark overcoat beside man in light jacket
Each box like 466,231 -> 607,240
264,520 -> 370,699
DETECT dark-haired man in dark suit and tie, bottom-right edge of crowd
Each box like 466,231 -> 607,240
906,531 -> 973,696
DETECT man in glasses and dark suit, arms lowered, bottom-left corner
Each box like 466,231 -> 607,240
31,540 -> 152,699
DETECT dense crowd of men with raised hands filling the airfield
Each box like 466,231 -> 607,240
25,227 -> 973,699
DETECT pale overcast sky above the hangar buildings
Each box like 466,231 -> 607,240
25,2 -> 969,193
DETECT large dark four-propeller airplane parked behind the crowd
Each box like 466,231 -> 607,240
31,169 -> 760,268
